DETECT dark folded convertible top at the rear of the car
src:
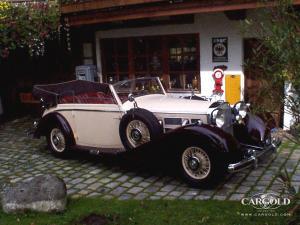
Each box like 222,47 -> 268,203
32,80 -> 110,105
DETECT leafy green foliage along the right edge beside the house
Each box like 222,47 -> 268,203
243,0 -> 300,140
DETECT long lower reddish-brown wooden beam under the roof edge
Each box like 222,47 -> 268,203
68,0 -> 300,26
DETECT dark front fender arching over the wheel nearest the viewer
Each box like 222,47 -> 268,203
130,124 -> 243,162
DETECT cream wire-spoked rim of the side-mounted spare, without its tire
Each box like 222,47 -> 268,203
126,120 -> 150,148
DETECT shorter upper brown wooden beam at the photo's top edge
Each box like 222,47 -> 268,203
61,0 -> 164,14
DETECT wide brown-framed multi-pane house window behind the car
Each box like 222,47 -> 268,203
100,34 -> 200,91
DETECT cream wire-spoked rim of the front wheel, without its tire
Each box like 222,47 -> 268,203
182,147 -> 211,180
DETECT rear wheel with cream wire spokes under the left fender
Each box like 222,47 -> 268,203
47,126 -> 69,158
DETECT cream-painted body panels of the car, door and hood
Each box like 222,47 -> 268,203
43,79 -> 214,151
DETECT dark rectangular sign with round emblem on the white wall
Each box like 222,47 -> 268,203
212,37 -> 228,62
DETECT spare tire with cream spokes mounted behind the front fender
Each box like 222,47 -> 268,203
119,108 -> 163,150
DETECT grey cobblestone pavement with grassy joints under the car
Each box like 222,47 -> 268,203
0,118 -> 300,201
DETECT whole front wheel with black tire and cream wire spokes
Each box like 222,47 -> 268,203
179,145 -> 225,188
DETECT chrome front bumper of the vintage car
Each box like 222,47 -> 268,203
228,141 -> 281,173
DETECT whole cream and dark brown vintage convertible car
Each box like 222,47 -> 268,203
33,77 -> 280,186
